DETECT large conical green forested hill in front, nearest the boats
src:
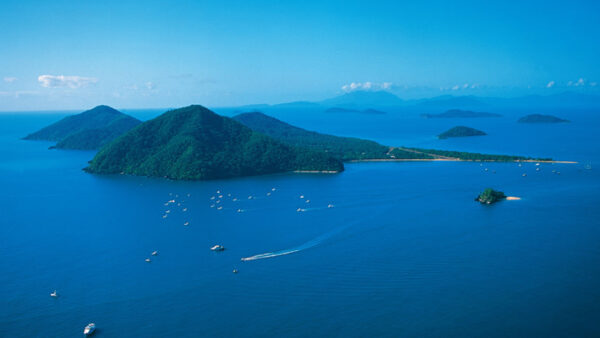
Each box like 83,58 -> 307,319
86,106 -> 344,180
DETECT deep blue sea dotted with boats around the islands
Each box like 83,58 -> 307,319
0,109 -> 600,337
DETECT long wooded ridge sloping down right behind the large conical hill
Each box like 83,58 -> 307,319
233,112 -> 390,161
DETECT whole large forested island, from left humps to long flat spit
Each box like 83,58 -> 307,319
27,105 -> 542,180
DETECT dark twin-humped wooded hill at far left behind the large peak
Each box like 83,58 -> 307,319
23,106 -> 142,150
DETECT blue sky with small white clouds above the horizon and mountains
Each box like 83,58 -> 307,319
0,0 -> 600,111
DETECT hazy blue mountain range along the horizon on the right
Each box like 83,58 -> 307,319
240,91 -> 600,111
